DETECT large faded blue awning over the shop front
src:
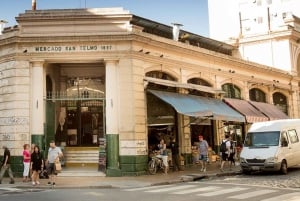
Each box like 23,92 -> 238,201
148,90 -> 245,122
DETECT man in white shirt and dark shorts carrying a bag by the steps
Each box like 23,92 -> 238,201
46,140 -> 63,186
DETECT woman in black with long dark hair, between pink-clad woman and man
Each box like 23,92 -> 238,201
30,145 -> 44,186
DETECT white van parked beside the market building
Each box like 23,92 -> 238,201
240,119 -> 300,174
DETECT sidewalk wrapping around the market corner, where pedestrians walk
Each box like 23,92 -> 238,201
0,162 -> 241,189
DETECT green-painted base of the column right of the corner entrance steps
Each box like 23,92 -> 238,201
106,134 -> 122,177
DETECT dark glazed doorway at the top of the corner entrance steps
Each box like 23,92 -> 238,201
59,100 -> 104,146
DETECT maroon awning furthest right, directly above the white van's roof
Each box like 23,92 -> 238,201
249,101 -> 289,120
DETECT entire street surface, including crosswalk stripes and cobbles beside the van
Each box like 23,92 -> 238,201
0,168 -> 300,201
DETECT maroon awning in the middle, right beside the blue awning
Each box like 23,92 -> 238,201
224,98 -> 269,123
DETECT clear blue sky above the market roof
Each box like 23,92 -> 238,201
0,0 -> 209,37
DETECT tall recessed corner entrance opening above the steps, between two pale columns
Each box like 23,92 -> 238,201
46,63 -> 105,147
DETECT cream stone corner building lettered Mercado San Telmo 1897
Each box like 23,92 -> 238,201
0,8 -> 299,176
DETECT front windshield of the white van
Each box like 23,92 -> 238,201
244,131 -> 280,147
